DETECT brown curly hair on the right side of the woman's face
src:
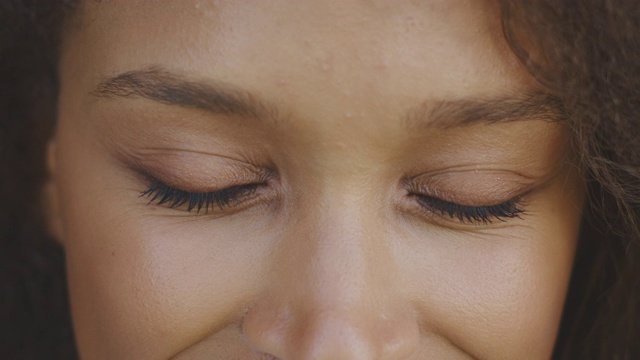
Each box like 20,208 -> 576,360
502,0 -> 640,359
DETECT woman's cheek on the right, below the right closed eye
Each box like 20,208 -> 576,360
405,177 -> 582,359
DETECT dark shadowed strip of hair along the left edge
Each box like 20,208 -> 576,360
0,0 -> 77,359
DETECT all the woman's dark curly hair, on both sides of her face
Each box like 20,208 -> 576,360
0,0 -> 640,360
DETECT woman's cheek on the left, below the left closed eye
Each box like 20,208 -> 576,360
57,129 -> 270,359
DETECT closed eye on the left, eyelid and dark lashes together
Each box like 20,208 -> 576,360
127,149 -> 277,216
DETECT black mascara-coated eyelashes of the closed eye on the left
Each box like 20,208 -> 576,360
140,179 -> 264,214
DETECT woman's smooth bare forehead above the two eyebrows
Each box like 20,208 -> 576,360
65,0 -> 528,111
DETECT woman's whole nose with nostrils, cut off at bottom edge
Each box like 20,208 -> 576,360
243,204 -> 419,360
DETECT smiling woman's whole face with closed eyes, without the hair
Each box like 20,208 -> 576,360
49,0 -> 582,359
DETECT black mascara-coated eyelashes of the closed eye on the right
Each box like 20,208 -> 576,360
412,194 -> 525,225
